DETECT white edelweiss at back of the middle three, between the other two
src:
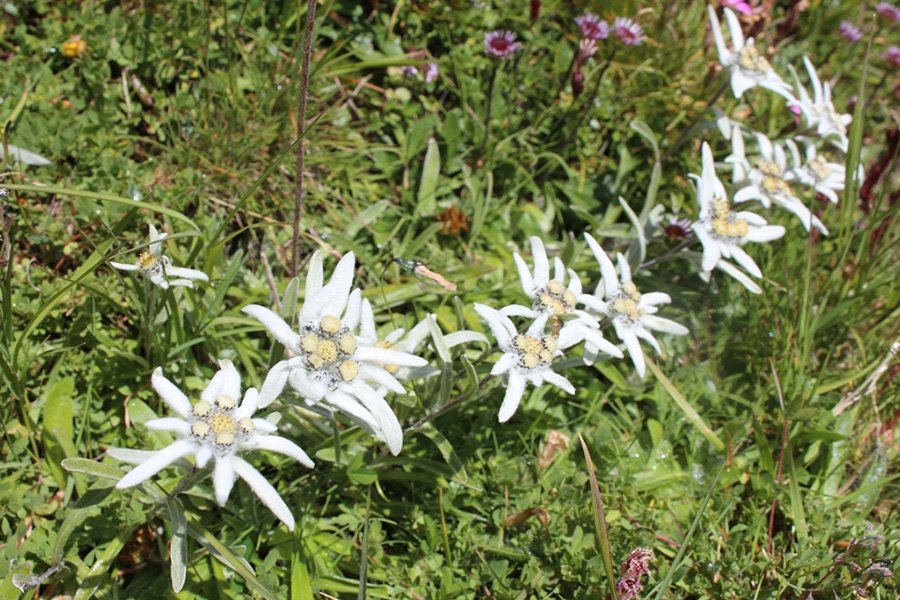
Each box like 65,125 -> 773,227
500,236 -> 622,358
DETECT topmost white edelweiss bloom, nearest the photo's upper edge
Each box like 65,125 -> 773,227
707,6 -> 796,104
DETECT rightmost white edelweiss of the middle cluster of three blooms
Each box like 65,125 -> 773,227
578,233 -> 688,377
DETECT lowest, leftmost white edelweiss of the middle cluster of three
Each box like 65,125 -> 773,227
475,303 -> 575,423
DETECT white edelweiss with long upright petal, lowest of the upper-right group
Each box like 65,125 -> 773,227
691,142 -> 785,294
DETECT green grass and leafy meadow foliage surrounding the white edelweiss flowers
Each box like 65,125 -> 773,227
0,0 -> 900,600
